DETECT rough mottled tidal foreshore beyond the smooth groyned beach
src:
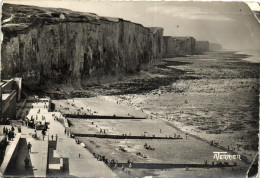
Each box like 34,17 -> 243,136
104,50 -> 259,162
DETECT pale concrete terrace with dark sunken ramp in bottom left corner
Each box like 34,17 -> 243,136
1,126 -> 48,177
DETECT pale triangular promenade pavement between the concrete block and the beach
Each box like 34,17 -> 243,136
49,113 -> 116,178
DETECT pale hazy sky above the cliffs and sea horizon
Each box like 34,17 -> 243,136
3,0 -> 260,50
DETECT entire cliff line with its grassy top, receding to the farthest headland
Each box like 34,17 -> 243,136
1,4 -> 221,87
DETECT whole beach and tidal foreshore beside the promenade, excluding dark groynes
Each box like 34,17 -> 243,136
50,51 -> 259,177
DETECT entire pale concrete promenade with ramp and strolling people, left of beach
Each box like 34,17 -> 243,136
0,99 -> 117,178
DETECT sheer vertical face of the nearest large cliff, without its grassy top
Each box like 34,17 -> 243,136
2,3 -> 163,86
